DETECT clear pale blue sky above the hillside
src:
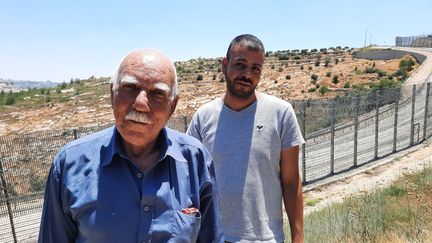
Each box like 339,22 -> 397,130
0,0 -> 432,82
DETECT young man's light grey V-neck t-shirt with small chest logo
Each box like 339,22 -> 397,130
187,93 -> 304,242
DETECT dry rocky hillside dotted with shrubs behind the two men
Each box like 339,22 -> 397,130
0,48 -> 418,135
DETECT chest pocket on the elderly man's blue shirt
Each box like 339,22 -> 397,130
173,210 -> 201,243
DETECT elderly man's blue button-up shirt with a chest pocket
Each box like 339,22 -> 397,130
39,127 -> 222,243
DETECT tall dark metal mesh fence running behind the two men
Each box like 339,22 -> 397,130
0,82 -> 432,243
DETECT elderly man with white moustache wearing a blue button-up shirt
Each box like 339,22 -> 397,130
39,49 -> 222,243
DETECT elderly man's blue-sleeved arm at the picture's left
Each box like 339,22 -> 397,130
38,160 -> 77,243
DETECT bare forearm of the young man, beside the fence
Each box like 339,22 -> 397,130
280,145 -> 304,242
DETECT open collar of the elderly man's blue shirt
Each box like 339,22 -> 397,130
100,126 -> 187,166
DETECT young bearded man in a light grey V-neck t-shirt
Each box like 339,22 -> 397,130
187,34 -> 304,242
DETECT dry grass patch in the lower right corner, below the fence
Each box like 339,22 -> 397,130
286,168 -> 432,242
